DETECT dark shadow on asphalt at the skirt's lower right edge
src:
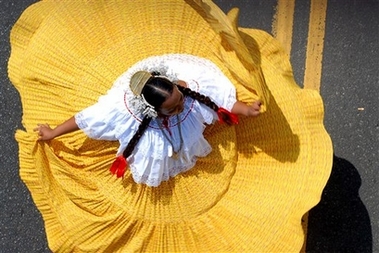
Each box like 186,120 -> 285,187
306,156 -> 372,253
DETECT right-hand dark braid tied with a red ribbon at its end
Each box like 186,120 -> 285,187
177,85 -> 235,125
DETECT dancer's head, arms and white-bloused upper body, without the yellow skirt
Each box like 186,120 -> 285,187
34,55 -> 260,186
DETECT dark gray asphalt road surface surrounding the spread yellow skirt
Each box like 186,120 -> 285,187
0,0 -> 379,253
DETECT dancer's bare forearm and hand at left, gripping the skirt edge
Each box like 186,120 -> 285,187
34,117 -> 79,141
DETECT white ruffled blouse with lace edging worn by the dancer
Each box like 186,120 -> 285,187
75,54 -> 236,186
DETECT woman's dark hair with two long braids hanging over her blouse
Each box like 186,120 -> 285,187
123,72 -> 235,159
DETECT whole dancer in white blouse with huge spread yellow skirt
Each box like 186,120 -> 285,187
9,0 -> 332,252
